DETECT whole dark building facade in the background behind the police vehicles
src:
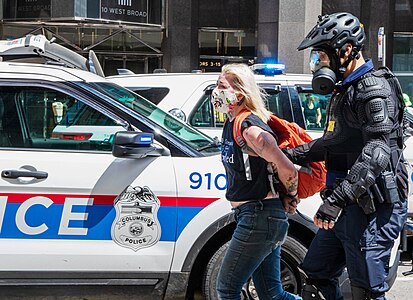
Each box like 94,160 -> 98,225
0,0 -> 413,91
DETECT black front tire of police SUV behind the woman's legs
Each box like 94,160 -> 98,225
202,236 -> 307,300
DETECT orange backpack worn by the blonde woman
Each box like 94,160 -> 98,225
233,110 -> 326,199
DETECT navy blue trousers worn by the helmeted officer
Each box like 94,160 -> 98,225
302,200 -> 407,300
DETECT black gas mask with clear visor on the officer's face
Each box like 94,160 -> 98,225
310,49 -> 344,95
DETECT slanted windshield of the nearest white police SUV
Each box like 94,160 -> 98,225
83,82 -> 219,153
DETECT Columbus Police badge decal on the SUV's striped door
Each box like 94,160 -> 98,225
111,186 -> 161,251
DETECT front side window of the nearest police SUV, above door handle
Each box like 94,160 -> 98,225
0,87 -> 125,151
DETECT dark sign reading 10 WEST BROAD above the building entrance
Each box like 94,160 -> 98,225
100,0 -> 149,23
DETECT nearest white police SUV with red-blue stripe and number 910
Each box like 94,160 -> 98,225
0,36 -> 399,299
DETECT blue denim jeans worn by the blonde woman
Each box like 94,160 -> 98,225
217,198 -> 301,300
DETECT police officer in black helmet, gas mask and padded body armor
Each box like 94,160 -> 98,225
287,12 -> 408,300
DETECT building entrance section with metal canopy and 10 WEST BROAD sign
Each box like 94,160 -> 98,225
0,0 -> 166,75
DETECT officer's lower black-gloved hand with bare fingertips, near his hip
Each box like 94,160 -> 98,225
314,191 -> 345,230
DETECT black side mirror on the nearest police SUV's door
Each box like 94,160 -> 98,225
112,131 -> 166,158
